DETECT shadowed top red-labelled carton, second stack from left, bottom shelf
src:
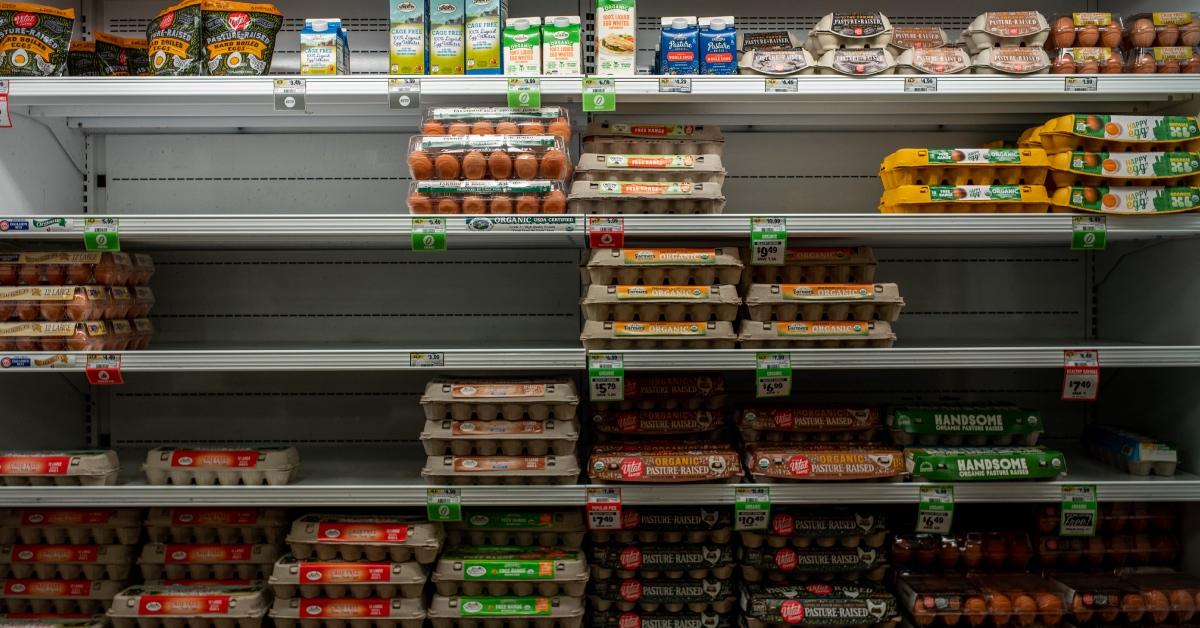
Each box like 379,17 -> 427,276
145,508 -> 288,545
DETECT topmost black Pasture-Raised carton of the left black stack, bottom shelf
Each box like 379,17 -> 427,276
589,506 -> 733,545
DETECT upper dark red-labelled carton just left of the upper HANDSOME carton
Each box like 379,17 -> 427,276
737,403 -> 883,443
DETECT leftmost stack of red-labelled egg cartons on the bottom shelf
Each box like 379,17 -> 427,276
0,508 -> 142,618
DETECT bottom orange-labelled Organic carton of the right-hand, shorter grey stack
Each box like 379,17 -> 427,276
738,321 -> 896,349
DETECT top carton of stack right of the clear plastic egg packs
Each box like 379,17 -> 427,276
583,120 -> 725,156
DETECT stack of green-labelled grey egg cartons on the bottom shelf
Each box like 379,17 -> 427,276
430,509 -> 588,628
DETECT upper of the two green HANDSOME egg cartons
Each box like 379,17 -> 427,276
888,405 -> 1045,447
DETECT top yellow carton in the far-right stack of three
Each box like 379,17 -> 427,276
1038,113 -> 1200,155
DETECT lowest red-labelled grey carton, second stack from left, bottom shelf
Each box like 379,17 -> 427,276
108,582 -> 269,628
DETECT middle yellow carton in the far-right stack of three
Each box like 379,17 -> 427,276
1050,150 -> 1200,187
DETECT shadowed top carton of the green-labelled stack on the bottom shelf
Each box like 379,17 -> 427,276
445,508 -> 587,549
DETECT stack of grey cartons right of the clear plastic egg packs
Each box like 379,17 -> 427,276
568,121 -> 725,214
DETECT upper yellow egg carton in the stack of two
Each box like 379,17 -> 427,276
880,148 -> 1050,190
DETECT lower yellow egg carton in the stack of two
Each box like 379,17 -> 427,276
880,185 -> 1050,214
